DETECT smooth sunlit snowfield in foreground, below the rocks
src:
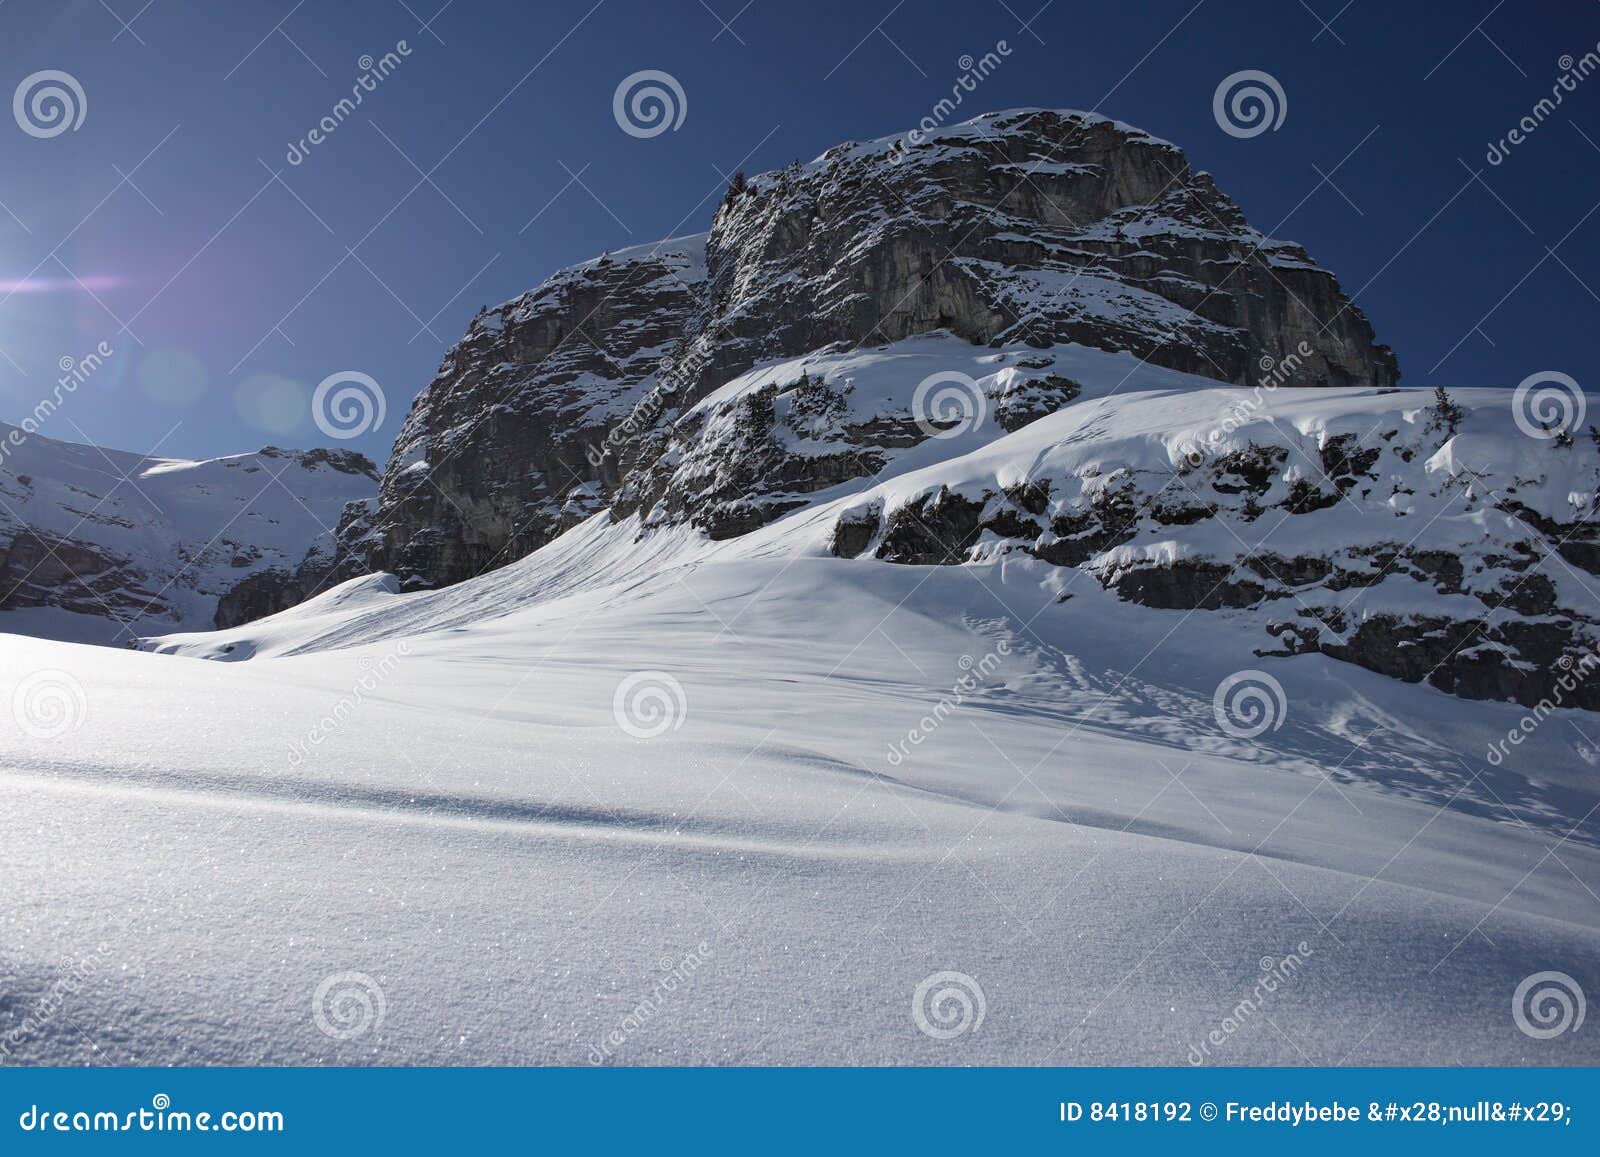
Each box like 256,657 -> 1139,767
9,342 -> 1600,1064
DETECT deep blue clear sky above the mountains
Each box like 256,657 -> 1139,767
0,0 -> 1600,459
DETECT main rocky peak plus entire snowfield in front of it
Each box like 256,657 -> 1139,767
0,110 -> 1600,1064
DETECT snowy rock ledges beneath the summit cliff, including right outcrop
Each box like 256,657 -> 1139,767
643,336 -> 1600,709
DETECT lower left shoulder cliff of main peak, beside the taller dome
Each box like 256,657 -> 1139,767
371,237 -> 706,586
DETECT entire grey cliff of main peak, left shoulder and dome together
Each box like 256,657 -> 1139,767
363,110 -> 1398,584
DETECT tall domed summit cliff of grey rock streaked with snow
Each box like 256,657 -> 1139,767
681,110 -> 1398,386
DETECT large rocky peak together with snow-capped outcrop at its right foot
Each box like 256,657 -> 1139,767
318,109 -> 1600,706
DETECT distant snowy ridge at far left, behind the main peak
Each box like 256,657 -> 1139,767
0,424 -> 376,645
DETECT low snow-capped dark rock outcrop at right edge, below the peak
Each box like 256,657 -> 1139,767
832,376 -> 1600,709
